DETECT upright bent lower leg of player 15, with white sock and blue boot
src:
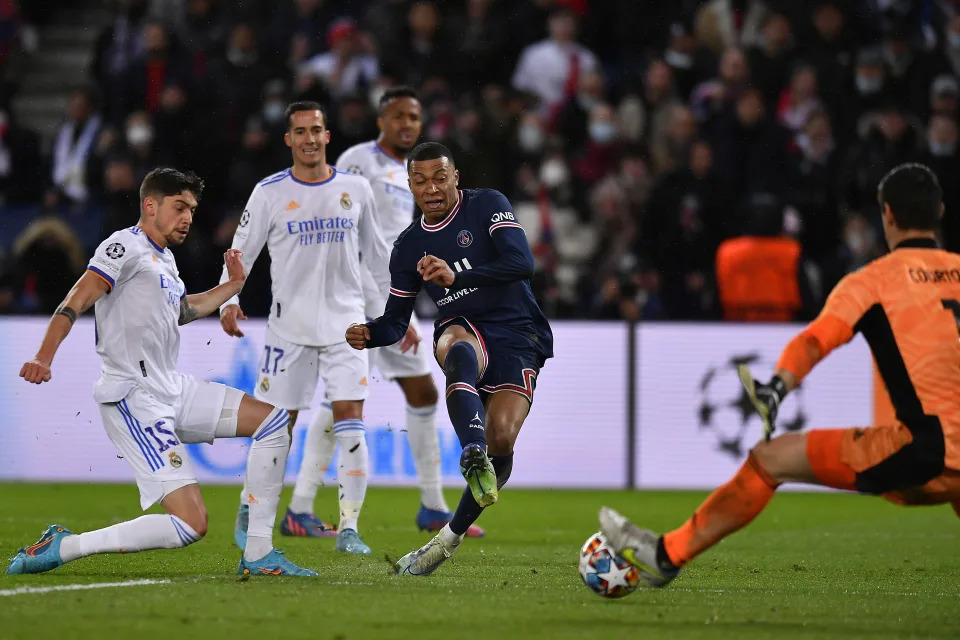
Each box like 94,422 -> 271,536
237,395 -> 317,576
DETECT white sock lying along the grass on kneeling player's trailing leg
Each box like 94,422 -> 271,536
60,513 -> 200,562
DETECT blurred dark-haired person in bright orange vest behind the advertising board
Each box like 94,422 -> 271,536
716,194 -> 803,322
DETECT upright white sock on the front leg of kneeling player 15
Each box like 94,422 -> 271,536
243,409 -> 290,561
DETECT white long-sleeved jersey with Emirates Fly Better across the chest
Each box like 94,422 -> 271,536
220,169 -> 390,347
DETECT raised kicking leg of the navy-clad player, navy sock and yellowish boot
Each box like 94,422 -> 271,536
444,341 -> 497,507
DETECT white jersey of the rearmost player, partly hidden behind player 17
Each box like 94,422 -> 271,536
337,140 -> 416,319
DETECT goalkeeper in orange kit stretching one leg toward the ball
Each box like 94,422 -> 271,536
600,164 -> 960,587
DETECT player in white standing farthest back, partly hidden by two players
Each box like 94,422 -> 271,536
284,87 -> 483,537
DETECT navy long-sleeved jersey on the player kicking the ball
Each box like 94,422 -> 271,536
367,189 -> 553,358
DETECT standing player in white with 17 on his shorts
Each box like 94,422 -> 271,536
220,102 -> 390,553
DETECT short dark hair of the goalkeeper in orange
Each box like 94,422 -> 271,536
877,162 -> 943,231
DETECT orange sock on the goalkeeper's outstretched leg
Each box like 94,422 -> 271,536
663,453 -> 779,567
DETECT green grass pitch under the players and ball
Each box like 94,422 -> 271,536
0,484 -> 960,640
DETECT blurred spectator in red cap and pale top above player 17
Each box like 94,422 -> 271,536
298,18 -> 380,98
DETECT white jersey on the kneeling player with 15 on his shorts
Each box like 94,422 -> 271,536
87,227 -> 186,404
